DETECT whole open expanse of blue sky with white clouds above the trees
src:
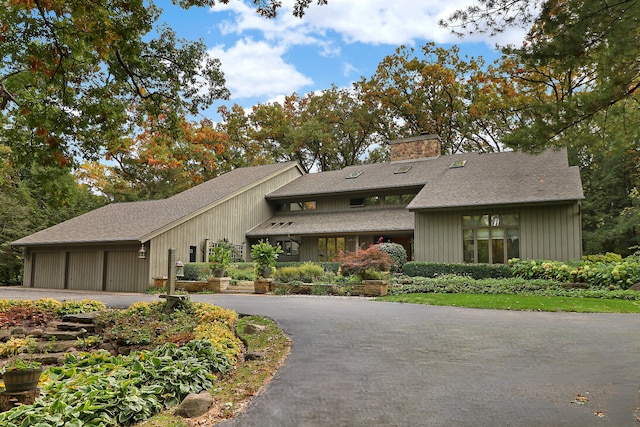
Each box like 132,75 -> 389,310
202,0 -> 525,99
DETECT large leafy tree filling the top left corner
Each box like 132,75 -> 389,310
0,0 -> 228,166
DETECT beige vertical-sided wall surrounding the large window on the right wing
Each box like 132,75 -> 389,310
414,203 -> 582,263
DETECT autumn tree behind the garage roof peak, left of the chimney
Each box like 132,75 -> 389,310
218,86 -> 384,172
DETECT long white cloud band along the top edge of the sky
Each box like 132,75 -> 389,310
212,0 -> 526,47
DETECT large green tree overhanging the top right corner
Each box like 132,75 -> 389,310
443,0 -> 640,151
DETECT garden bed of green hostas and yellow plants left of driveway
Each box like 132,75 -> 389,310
0,300 -> 244,427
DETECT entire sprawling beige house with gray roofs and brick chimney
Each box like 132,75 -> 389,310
13,135 -> 584,291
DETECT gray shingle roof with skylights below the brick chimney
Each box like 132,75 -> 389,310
267,150 -> 584,209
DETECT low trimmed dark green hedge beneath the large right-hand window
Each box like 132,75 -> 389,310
402,261 -> 511,279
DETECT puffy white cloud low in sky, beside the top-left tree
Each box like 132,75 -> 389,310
208,39 -> 313,99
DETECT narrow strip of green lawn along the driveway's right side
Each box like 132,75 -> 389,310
378,293 -> 640,313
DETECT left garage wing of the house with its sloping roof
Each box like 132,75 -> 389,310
12,162 -> 303,292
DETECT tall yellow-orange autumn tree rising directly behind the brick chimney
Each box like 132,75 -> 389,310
358,43 -> 512,153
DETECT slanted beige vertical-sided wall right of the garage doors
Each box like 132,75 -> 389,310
148,169 -> 300,286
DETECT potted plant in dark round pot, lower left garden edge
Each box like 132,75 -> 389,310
0,336 -> 42,393
